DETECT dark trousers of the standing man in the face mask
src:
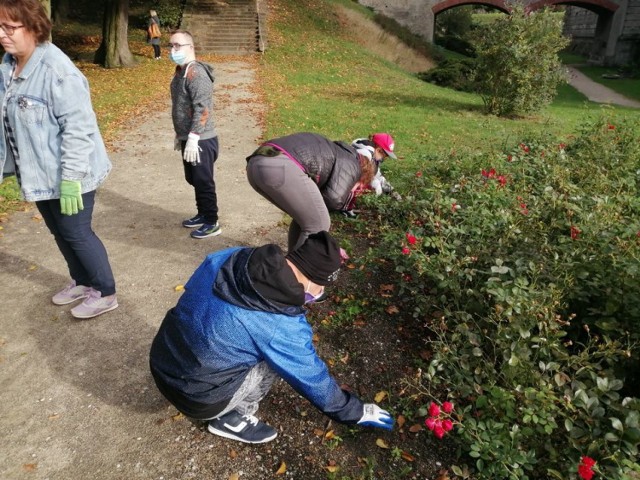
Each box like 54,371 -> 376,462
182,137 -> 218,225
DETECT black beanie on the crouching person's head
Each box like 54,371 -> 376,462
287,232 -> 341,286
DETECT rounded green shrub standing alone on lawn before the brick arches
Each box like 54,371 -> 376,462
476,4 -> 568,116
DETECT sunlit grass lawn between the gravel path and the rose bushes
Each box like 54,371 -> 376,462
260,0 -> 640,187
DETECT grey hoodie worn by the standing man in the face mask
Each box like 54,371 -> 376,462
171,60 -> 217,140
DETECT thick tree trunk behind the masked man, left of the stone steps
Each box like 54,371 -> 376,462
94,0 -> 136,68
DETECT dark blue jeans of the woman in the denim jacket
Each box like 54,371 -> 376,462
36,190 -> 116,297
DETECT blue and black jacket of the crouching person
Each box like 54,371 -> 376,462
150,248 -> 363,424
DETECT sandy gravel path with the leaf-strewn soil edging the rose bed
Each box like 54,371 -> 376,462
0,58 -> 450,480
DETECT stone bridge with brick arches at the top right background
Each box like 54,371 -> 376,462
359,0 -> 640,65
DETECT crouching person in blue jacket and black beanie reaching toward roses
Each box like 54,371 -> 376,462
150,232 -> 393,443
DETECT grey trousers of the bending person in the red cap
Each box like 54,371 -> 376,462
247,155 -> 331,252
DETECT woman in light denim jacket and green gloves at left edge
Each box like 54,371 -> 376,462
0,0 -> 118,318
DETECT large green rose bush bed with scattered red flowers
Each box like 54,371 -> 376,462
363,113 -> 640,480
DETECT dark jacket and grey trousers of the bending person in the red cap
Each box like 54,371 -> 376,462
247,132 -> 376,252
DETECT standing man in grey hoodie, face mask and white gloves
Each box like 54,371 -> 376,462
169,30 -> 222,239
